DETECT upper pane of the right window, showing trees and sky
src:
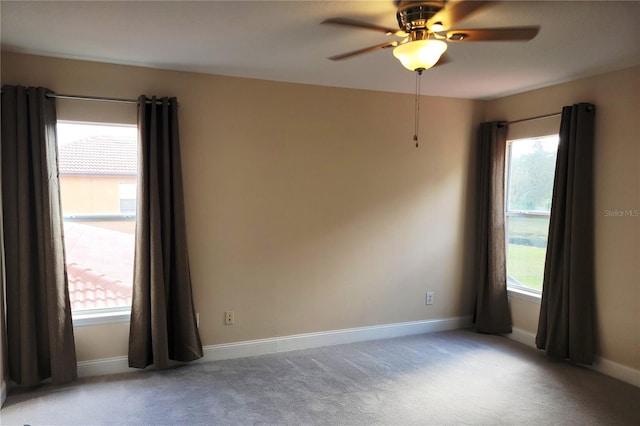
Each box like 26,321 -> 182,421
507,136 -> 558,213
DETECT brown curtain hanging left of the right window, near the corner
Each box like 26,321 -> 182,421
475,122 -> 511,334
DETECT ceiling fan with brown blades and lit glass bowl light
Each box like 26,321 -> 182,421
322,0 -> 540,74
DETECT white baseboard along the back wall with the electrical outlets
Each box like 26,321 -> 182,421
78,317 -> 471,377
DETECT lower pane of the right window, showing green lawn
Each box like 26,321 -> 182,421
507,216 -> 549,290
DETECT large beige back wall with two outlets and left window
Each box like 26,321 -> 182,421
2,53 -> 482,360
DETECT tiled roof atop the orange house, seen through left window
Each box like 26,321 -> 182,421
58,136 -> 137,176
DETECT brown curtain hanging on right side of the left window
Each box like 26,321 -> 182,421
129,96 -> 202,369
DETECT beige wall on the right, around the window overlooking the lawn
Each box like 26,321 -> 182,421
486,67 -> 640,369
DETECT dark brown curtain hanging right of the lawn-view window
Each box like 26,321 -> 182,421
536,104 -> 595,364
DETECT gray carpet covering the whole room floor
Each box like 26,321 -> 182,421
0,331 -> 640,425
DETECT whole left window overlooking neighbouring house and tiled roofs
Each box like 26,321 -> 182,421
57,122 -> 137,320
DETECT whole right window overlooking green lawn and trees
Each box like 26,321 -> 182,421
505,136 -> 558,294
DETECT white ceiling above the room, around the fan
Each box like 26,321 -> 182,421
0,0 -> 640,99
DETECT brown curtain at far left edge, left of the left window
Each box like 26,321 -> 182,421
2,86 -> 77,386
